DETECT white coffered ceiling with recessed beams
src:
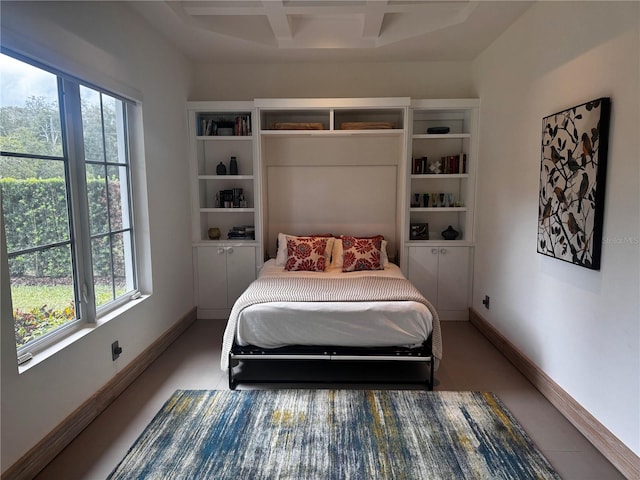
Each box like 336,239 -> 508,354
130,0 -> 532,63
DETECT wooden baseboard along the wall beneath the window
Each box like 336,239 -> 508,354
2,308 -> 196,480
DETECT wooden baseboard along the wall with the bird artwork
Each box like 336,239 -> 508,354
469,308 -> 640,478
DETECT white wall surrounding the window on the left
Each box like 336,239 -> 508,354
1,2 -> 194,471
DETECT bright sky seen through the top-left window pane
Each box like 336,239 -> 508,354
0,54 -> 58,107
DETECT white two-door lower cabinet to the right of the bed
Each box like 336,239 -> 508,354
407,246 -> 470,320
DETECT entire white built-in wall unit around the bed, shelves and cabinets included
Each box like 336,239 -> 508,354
188,97 -> 479,320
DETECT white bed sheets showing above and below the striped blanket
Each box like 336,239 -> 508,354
235,260 -> 433,348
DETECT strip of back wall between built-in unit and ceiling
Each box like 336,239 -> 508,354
190,62 -> 476,100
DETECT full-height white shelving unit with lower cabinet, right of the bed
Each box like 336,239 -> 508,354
401,99 -> 479,320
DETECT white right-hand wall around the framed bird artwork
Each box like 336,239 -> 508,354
473,2 -> 640,454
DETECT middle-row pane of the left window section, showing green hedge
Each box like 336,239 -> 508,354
0,157 -> 70,253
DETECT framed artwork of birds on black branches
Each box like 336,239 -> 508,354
538,97 -> 611,270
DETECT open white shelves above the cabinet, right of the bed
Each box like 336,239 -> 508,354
405,99 -> 479,245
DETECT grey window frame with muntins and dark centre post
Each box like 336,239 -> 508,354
0,48 -> 141,360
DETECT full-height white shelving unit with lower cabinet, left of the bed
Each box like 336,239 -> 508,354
187,102 -> 262,318
